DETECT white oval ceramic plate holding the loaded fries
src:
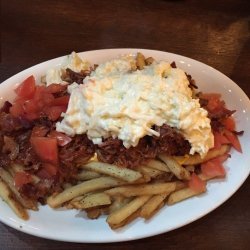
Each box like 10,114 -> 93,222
0,49 -> 250,243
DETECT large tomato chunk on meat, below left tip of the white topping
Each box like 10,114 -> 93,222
30,136 -> 58,165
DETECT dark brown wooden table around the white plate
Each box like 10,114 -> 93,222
0,0 -> 250,250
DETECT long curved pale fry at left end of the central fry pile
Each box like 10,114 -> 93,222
47,177 -> 124,208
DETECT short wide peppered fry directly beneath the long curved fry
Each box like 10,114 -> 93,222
72,193 -> 111,209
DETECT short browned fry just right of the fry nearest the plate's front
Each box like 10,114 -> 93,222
140,194 -> 168,220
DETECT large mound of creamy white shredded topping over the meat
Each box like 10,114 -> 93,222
56,54 -> 214,156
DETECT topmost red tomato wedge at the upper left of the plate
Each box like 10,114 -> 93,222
15,76 -> 36,98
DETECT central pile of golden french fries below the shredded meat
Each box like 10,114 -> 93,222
47,145 -> 230,229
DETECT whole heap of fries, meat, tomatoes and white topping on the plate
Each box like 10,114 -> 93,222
0,52 -> 242,229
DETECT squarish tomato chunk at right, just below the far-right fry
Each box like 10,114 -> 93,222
201,159 -> 226,178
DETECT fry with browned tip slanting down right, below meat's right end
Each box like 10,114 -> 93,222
159,155 -> 190,180
